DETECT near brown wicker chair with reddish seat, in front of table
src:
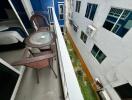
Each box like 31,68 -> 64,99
11,48 -> 57,83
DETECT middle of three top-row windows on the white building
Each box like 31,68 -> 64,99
85,3 -> 97,20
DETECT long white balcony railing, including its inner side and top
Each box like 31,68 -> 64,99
52,8 -> 84,100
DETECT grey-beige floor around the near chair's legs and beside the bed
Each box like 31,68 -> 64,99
0,50 -> 64,100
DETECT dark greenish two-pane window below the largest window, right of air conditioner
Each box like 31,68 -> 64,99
91,45 -> 106,63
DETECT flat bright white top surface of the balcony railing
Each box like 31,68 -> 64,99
52,8 -> 84,100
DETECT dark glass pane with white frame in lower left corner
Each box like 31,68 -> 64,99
0,59 -> 20,100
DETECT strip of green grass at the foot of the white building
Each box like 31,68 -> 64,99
66,36 -> 98,100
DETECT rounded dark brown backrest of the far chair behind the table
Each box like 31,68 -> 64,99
30,13 -> 50,29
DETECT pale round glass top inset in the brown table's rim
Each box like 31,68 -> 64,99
29,32 -> 53,45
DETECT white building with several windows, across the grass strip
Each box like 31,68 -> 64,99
65,0 -> 132,100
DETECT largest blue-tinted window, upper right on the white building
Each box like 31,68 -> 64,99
103,8 -> 132,37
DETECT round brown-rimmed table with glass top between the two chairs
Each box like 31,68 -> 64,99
25,30 -> 56,48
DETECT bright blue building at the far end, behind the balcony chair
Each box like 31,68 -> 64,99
30,0 -> 64,33
